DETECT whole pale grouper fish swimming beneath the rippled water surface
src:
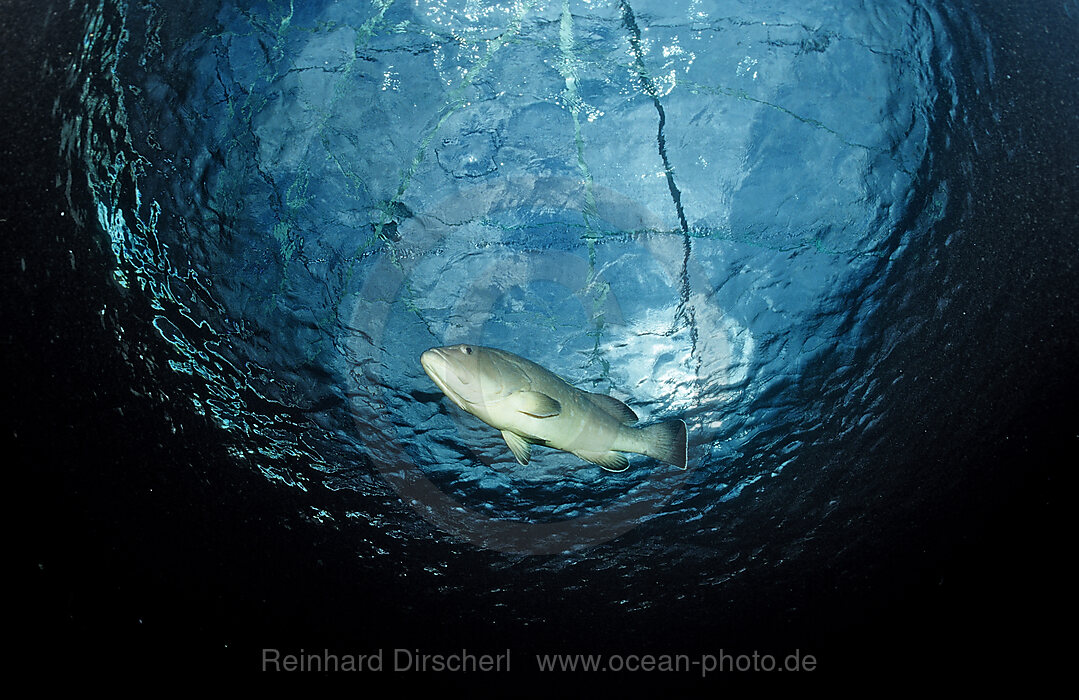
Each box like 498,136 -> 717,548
420,345 -> 687,471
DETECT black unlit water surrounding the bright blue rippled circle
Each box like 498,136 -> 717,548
0,0 -> 1079,690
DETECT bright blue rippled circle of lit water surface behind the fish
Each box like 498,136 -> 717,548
38,0 -> 1074,673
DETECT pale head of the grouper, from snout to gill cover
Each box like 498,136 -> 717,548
420,344 -> 529,415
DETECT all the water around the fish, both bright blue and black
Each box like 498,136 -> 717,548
3,2 -> 1079,683
